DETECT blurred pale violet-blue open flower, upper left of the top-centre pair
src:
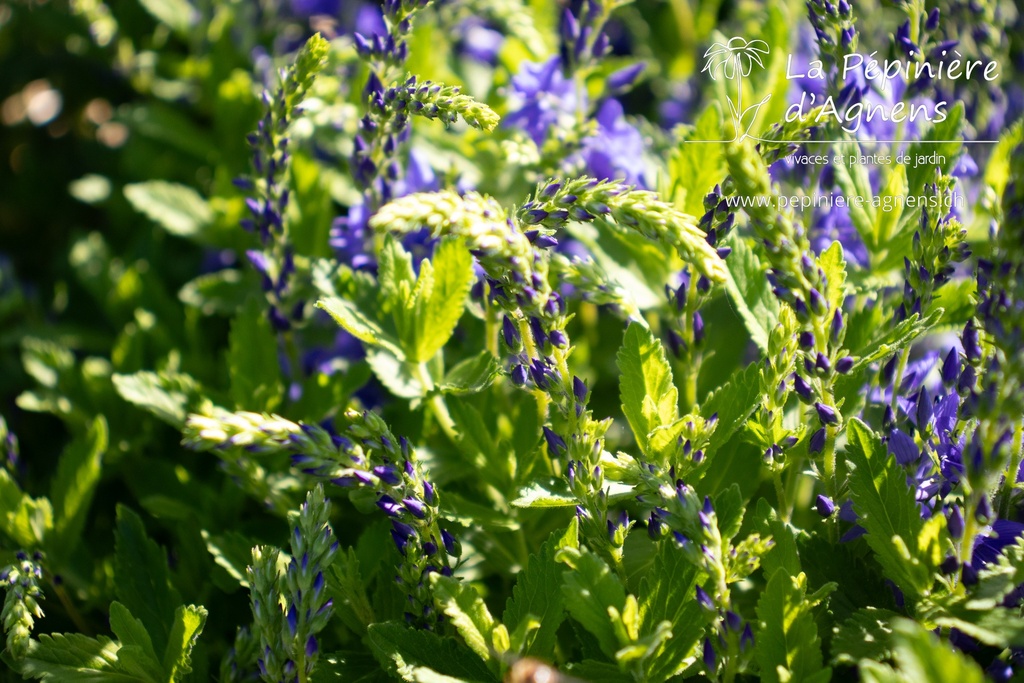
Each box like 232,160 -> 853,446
505,56 -> 583,145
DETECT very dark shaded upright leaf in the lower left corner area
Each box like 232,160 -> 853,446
114,505 -> 181,652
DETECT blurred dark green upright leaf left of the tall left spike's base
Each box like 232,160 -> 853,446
227,299 -> 283,413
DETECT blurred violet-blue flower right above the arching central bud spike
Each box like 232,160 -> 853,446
582,99 -> 647,188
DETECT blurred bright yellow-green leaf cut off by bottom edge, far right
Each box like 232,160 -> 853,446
892,618 -> 985,683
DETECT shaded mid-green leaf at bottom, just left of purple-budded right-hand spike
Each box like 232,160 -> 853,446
639,542 -> 706,683
